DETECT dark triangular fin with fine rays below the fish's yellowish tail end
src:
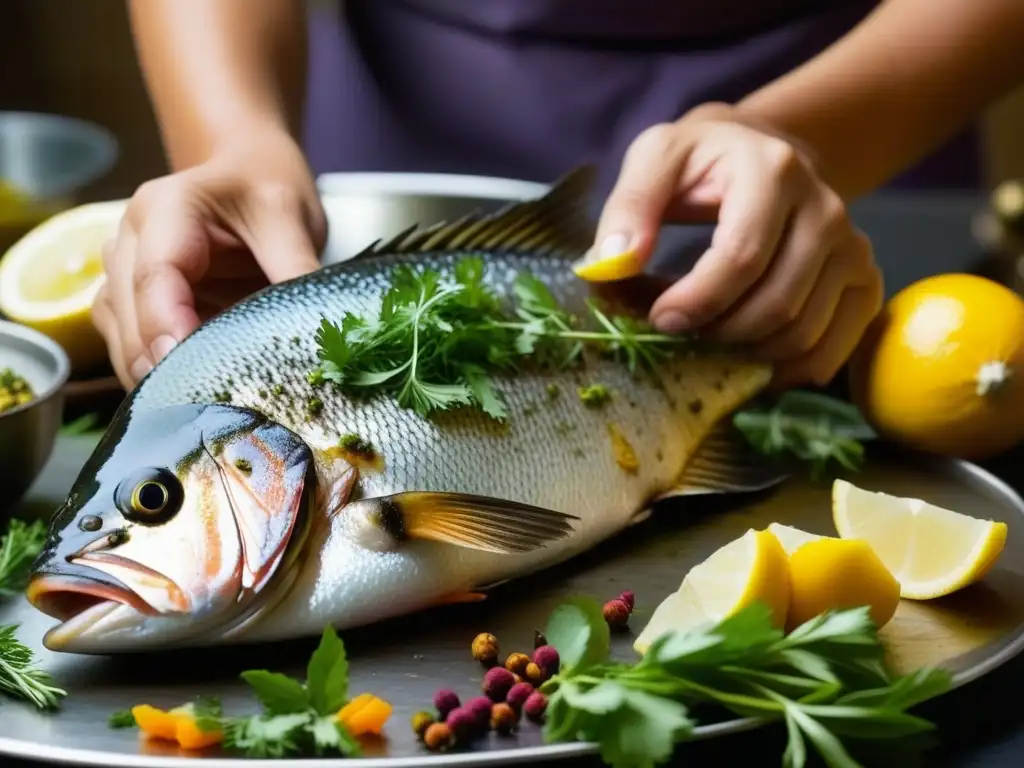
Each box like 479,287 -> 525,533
654,419 -> 788,501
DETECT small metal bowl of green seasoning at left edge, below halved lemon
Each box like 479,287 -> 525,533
0,321 -> 71,511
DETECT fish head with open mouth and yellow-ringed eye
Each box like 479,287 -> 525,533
27,404 -> 315,653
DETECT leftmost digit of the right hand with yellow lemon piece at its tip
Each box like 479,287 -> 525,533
577,124 -> 690,281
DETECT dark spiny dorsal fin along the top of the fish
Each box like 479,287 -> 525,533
345,165 -> 597,263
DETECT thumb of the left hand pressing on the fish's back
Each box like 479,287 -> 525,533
245,195 -> 321,283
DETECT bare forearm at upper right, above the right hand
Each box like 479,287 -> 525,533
737,0 -> 1024,199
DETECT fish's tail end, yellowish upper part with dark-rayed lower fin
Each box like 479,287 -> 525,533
655,358 -> 788,501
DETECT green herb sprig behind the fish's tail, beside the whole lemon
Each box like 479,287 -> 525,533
732,390 -> 877,477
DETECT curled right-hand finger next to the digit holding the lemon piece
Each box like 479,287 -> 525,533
650,139 -> 805,333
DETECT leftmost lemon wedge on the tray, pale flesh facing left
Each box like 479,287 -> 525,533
633,528 -> 790,653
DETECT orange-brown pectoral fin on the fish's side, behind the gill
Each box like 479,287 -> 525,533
345,492 -> 579,554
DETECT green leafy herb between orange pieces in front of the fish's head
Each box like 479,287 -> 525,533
111,627 -> 359,758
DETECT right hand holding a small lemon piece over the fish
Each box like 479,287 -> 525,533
586,104 -> 883,387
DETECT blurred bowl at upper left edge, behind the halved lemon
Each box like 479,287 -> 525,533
0,112 -> 119,253
